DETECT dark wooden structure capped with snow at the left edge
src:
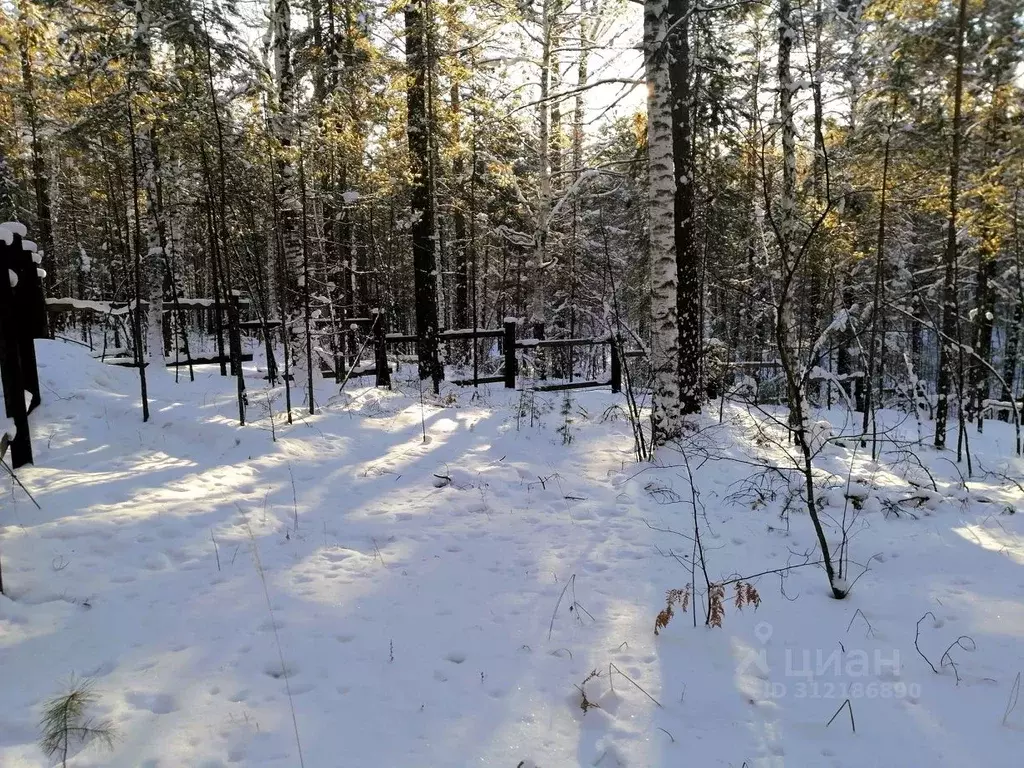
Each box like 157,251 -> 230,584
0,222 -> 46,469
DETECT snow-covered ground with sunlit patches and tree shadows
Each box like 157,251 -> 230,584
0,342 -> 1024,768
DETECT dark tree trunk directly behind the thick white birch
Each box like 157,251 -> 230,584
668,0 -> 701,414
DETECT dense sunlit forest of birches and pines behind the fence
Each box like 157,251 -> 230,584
0,0 -> 1024,447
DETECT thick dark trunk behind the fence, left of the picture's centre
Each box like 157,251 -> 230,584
406,0 -> 441,391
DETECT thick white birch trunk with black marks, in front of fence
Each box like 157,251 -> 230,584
644,0 -> 681,447
